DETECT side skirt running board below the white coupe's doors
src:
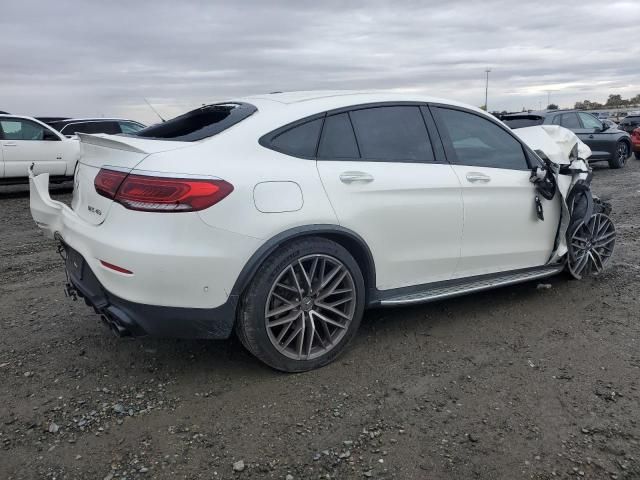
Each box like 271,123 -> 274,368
372,263 -> 564,306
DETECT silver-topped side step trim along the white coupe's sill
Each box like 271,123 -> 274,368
380,264 -> 564,306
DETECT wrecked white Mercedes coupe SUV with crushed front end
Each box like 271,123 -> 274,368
31,92 -> 615,371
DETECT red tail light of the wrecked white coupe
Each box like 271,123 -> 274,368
94,169 -> 233,212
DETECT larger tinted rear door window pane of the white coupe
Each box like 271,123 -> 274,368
350,106 -> 434,162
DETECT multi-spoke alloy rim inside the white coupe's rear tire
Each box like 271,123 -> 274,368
264,254 -> 357,360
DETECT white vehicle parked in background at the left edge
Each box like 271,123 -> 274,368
0,115 -> 80,184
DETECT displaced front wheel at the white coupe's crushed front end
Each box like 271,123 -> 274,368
567,213 -> 616,279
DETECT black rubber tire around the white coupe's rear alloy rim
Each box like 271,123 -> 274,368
236,237 -> 365,372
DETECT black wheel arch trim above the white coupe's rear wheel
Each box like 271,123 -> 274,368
231,225 -> 376,304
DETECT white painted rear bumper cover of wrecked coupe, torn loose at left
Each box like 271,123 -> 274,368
30,174 -> 261,311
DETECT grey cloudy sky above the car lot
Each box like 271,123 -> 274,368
0,0 -> 640,122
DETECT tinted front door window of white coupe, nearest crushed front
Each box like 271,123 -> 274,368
436,108 -> 529,170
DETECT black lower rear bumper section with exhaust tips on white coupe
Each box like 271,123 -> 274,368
63,244 -> 238,339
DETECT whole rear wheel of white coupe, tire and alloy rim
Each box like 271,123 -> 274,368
236,237 -> 365,372
